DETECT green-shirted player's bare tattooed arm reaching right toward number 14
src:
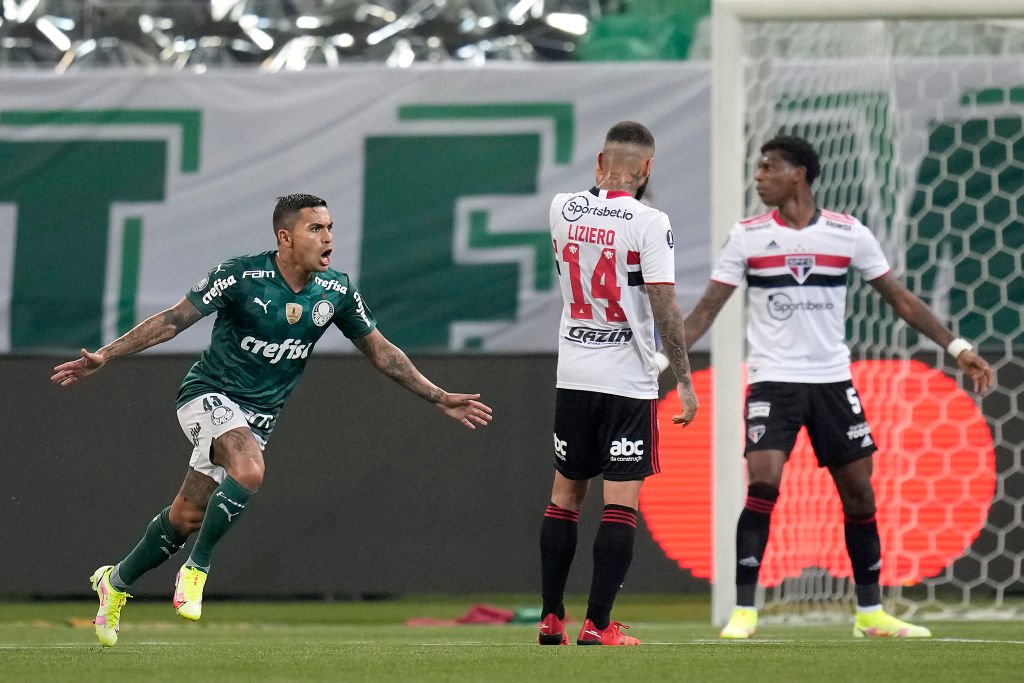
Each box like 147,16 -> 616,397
352,330 -> 490,429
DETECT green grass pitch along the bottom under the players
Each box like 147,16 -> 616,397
0,595 -> 1024,683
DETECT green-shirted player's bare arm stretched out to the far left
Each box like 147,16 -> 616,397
50,297 -> 203,386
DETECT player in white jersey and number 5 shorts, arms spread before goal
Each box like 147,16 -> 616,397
686,136 -> 992,638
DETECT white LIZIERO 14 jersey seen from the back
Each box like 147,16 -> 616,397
550,188 -> 676,398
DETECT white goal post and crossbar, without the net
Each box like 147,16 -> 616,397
711,0 -> 1024,626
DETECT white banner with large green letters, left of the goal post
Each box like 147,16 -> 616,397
0,63 -> 711,353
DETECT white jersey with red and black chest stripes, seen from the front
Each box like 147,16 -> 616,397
711,210 -> 890,383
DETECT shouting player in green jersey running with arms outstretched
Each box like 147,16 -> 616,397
50,195 -> 490,646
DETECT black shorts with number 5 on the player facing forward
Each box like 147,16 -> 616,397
744,380 -> 878,467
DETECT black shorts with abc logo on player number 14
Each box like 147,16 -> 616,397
554,389 -> 660,481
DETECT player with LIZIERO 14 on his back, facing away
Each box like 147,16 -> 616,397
539,121 -> 697,645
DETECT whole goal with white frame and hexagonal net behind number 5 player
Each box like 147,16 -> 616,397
712,0 -> 1024,623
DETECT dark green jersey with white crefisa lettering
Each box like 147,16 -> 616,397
177,251 -> 377,438
